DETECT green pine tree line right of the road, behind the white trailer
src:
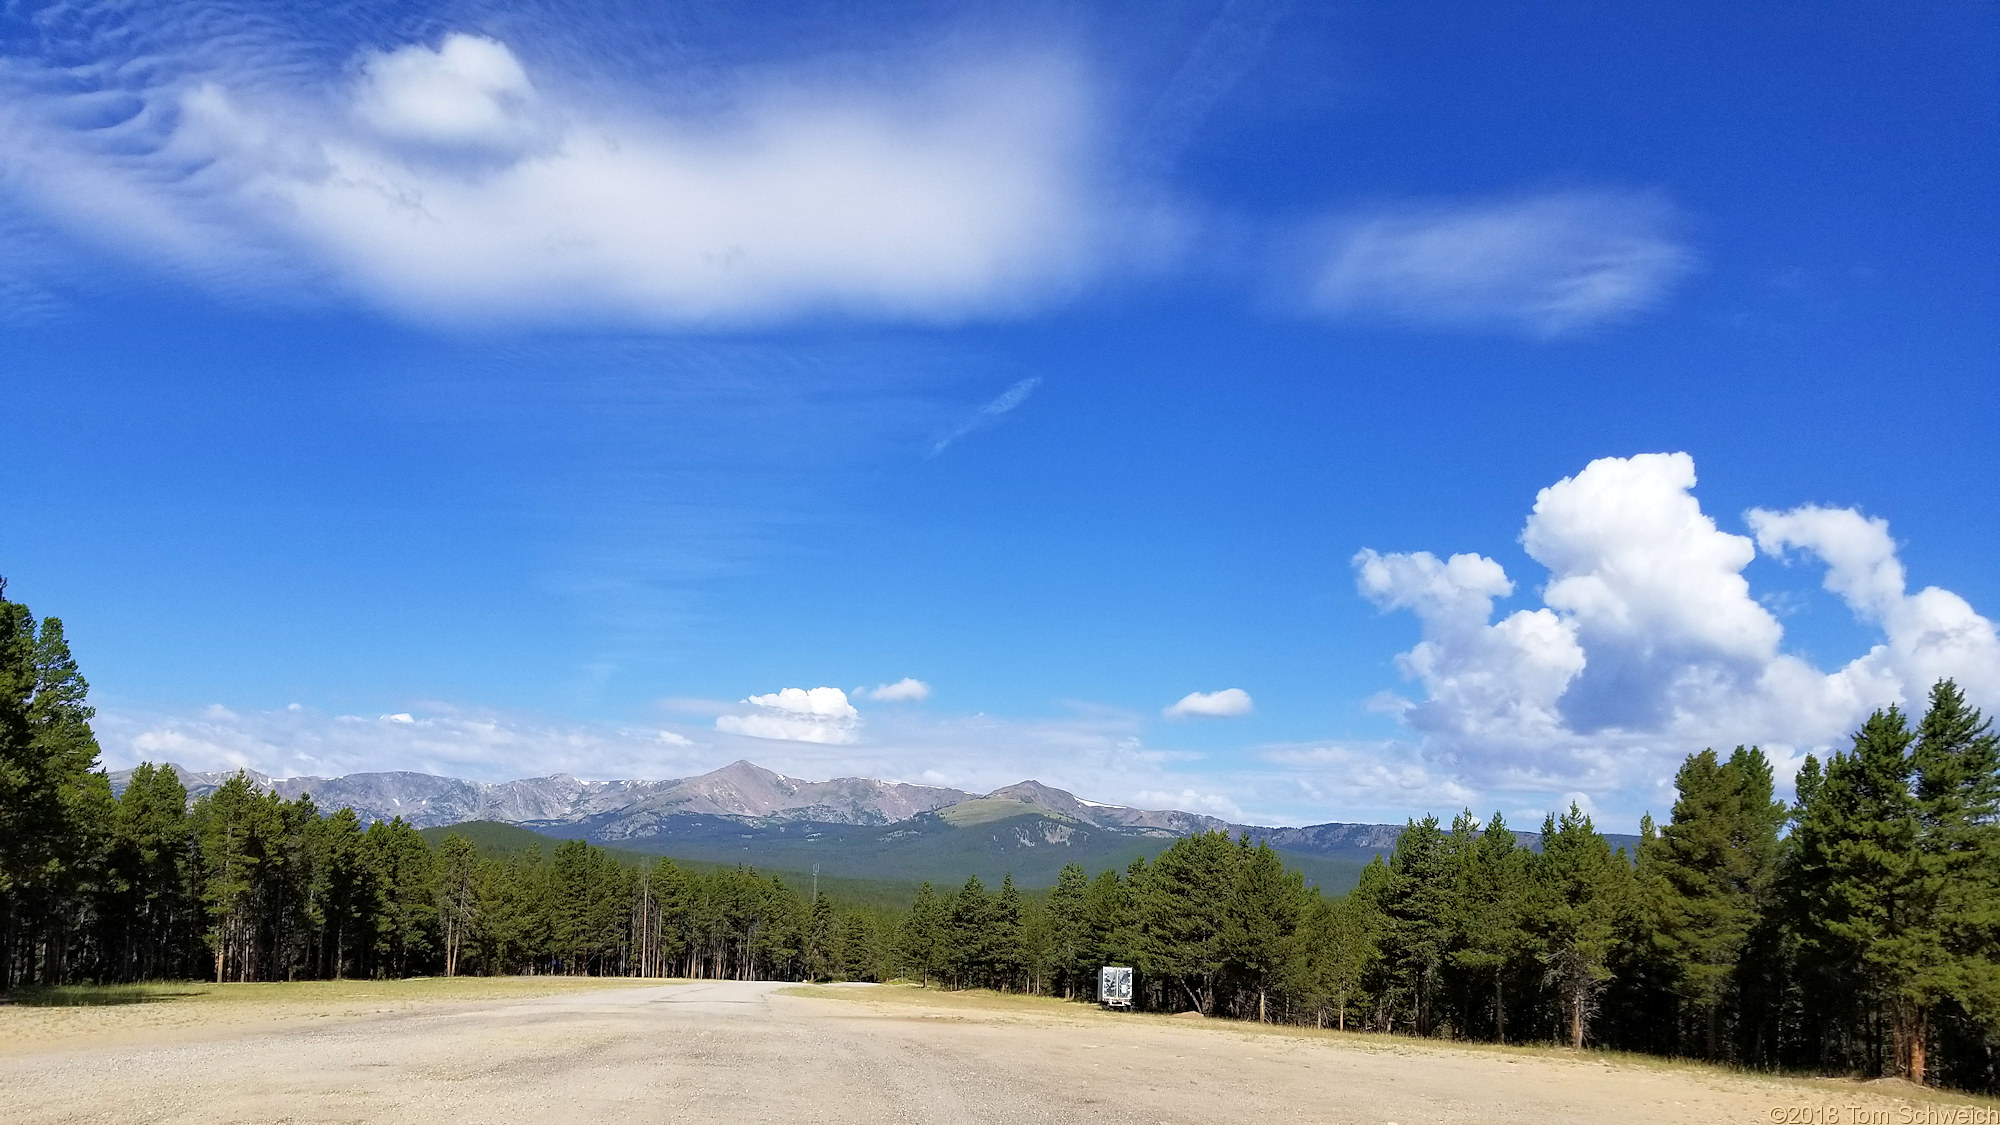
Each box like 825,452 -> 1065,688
896,681 -> 2000,1091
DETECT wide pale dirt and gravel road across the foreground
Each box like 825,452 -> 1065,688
0,983 -> 1968,1125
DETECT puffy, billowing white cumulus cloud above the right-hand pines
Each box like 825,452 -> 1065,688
1354,454 -> 2000,803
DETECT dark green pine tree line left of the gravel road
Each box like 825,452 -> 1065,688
0,583 -> 888,989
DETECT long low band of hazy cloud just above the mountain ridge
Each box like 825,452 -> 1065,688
94,693 -> 1538,825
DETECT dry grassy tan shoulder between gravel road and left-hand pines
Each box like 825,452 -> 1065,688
0,977 -> 664,1053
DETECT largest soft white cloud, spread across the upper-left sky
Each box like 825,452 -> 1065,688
0,32 -> 1158,326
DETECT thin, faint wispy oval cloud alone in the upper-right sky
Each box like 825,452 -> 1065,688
1308,190 -> 1694,336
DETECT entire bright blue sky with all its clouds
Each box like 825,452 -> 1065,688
0,0 -> 2000,831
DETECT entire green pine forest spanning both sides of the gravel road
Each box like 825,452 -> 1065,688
0,585 -> 2000,1091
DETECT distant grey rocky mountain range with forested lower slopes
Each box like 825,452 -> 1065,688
110,761 -> 1636,891
